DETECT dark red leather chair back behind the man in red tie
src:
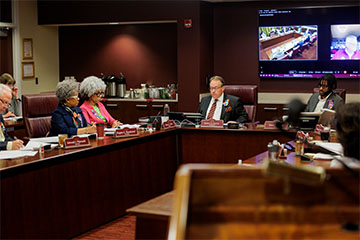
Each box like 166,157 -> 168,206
224,85 -> 258,122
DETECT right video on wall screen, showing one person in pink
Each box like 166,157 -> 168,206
330,24 -> 360,60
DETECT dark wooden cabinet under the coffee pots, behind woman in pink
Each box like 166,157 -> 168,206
104,100 -> 177,123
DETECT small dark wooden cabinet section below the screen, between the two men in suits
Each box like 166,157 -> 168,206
256,104 -> 287,123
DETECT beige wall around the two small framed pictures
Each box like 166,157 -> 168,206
16,0 -> 59,94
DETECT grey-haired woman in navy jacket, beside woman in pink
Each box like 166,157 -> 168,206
50,80 -> 96,136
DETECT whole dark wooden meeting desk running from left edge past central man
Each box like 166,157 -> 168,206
0,125 -> 292,239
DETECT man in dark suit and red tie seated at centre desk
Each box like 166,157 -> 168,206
198,76 -> 248,123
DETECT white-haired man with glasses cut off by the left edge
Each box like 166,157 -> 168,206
0,84 -> 24,150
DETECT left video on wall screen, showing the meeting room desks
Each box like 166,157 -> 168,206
259,25 -> 318,61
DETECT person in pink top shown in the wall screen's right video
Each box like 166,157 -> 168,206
331,35 -> 360,60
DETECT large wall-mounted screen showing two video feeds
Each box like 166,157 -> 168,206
258,6 -> 360,78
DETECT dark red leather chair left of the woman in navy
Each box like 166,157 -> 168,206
22,93 -> 58,138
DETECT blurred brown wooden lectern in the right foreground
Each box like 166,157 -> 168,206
168,163 -> 360,239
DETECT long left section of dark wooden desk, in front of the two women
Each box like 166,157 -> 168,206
1,131 -> 176,239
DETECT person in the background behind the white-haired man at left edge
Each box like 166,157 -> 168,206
0,73 -> 22,118
